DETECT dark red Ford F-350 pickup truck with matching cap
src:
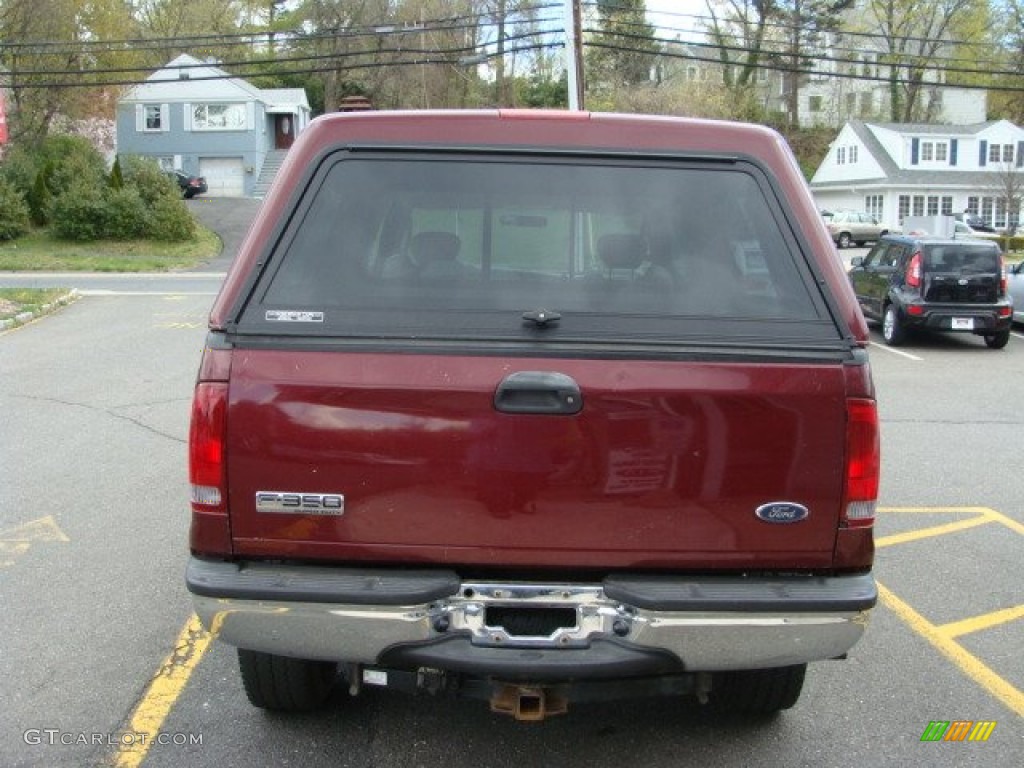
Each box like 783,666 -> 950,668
186,111 -> 880,720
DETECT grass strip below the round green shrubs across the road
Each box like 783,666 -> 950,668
0,225 -> 221,272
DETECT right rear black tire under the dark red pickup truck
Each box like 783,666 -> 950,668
708,664 -> 807,715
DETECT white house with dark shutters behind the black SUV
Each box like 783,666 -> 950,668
811,120 -> 1024,228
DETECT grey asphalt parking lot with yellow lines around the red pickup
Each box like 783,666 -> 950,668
0,237 -> 1024,768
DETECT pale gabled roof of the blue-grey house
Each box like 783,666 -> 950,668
121,53 -> 309,110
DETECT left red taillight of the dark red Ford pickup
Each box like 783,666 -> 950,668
188,382 -> 227,512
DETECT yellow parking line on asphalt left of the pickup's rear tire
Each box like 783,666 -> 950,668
114,614 -> 213,768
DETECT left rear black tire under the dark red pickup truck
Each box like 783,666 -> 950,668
239,648 -> 338,712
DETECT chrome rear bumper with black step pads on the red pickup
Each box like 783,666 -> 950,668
186,559 -> 877,679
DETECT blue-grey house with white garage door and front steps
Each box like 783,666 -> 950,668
117,54 -> 309,197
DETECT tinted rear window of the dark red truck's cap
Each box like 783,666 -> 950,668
240,152 -> 839,341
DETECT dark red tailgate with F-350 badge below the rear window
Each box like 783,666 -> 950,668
226,349 -> 846,569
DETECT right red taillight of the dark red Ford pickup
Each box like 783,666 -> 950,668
844,398 -> 882,527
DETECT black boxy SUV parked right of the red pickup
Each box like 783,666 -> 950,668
850,234 -> 1013,349
